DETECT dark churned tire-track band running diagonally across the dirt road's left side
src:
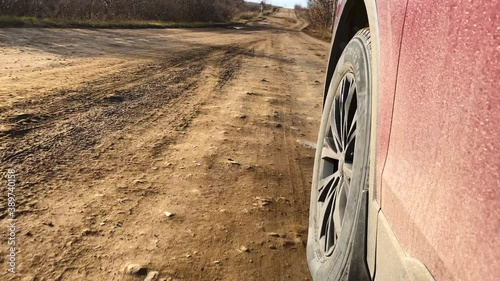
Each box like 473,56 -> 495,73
0,41 -> 258,221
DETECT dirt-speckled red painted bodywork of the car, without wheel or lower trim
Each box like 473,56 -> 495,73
327,0 -> 500,281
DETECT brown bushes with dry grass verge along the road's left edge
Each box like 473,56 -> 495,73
0,0 -> 268,28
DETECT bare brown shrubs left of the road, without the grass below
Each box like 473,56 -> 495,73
0,0 -> 251,22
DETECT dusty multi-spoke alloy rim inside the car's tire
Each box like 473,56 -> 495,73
316,73 -> 358,256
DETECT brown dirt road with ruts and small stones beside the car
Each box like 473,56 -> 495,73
0,10 -> 328,280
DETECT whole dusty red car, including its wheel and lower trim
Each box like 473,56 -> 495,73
307,0 -> 500,281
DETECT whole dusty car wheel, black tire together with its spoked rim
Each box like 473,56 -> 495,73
307,28 -> 371,281
